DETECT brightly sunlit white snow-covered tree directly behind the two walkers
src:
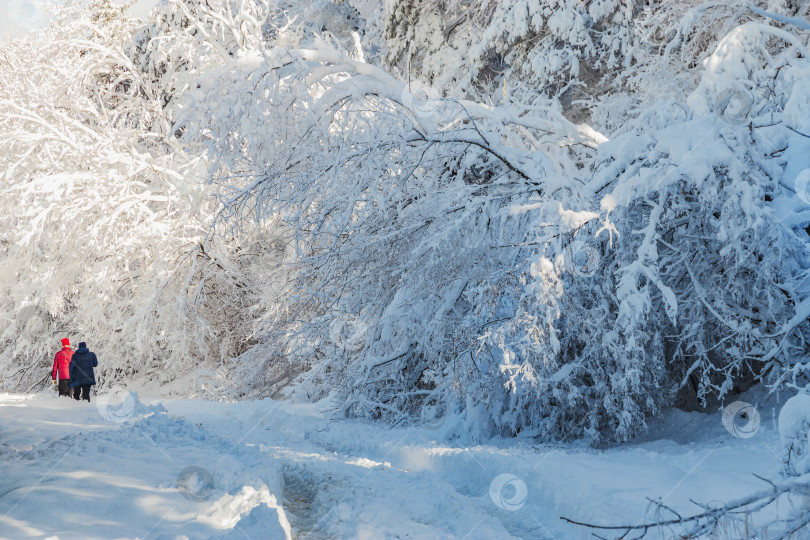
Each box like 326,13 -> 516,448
0,3 -> 252,390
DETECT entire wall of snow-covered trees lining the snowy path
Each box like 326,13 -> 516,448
0,0 -> 810,442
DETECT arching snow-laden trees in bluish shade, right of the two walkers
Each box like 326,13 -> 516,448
137,0 -> 807,440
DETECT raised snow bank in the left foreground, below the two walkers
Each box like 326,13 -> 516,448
0,393 -> 291,540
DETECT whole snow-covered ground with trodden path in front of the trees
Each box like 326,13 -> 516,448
0,394 -> 796,540
